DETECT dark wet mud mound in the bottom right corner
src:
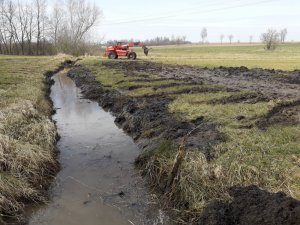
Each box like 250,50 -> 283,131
195,186 -> 300,225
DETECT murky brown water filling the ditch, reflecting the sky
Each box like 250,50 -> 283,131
29,73 -> 166,225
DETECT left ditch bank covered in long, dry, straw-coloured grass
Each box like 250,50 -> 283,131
0,60 -> 74,224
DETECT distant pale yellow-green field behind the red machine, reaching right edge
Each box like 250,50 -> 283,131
119,43 -> 300,70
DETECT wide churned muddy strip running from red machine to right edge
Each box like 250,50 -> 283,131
103,61 -> 300,99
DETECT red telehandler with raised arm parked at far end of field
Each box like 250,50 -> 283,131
105,42 -> 150,60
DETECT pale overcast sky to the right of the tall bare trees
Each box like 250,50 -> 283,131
90,0 -> 300,42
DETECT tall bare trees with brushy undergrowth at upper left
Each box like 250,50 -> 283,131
0,0 -> 102,55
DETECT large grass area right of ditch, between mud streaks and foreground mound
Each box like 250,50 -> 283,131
169,89 -> 300,202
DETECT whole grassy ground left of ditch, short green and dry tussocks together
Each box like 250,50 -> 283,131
0,55 -> 65,220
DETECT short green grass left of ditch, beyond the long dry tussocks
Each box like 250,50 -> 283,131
0,55 -> 65,111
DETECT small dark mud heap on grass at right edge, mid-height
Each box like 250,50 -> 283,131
257,99 -> 300,129
